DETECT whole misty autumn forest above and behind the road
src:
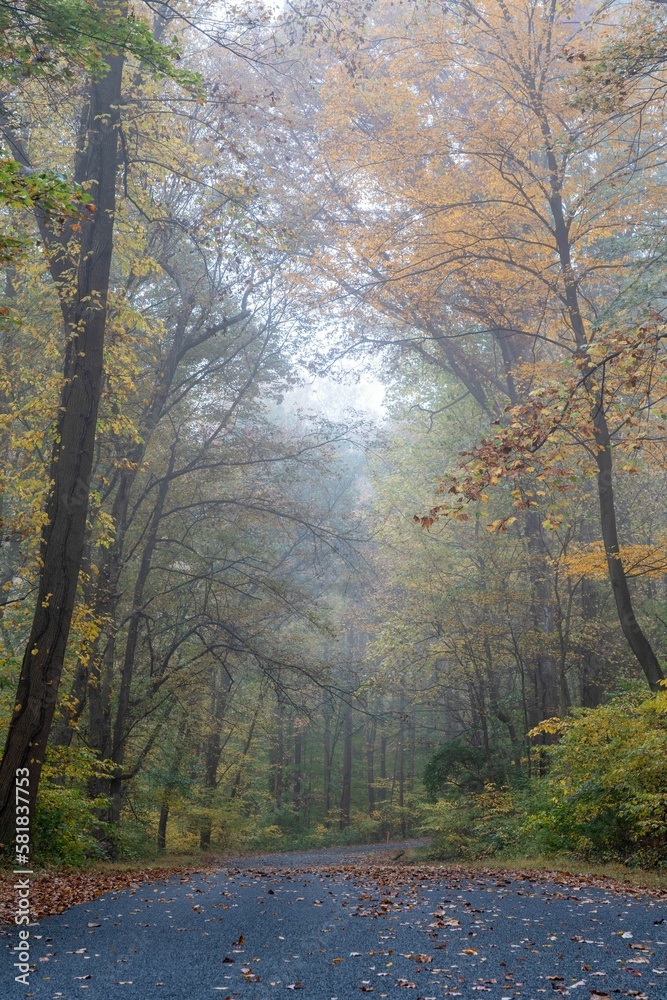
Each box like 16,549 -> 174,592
0,0 -> 667,864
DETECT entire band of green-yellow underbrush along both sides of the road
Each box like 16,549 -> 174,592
19,691 -> 667,870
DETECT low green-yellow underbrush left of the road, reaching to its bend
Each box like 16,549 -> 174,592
23,764 -> 424,868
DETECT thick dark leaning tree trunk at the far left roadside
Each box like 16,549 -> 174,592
0,39 -> 124,844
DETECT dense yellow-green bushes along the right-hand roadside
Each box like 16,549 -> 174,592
424,692 -> 667,868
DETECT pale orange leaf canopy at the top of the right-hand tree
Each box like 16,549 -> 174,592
319,2 -> 662,352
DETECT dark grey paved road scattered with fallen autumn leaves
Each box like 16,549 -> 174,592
0,848 -> 667,1000
